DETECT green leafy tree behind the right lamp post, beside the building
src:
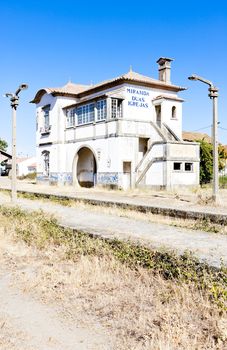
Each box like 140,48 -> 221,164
197,139 -> 226,185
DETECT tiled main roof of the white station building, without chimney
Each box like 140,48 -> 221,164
31,70 -> 186,103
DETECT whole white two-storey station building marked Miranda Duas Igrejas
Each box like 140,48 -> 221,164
32,58 -> 199,189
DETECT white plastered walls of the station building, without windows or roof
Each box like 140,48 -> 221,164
37,84 -> 198,186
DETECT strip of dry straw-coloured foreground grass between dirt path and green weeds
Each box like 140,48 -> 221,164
0,209 -> 227,350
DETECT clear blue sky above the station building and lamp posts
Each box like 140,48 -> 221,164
0,0 -> 227,155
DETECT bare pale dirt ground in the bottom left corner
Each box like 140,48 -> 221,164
0,229 -> 114,350
